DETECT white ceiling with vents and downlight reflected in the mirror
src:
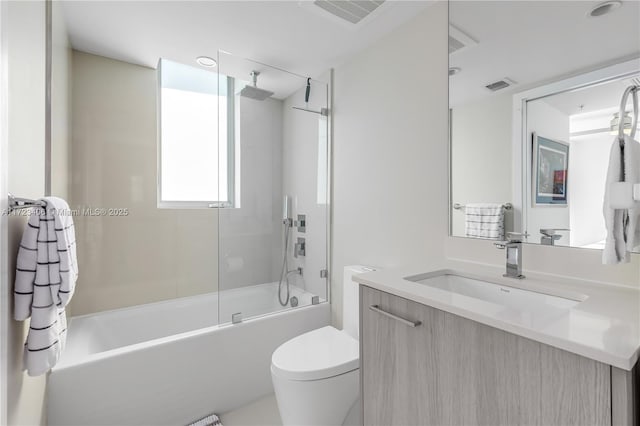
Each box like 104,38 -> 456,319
449,0 -> 640,106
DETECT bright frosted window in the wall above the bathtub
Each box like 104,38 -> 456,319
158,59 -> 234,207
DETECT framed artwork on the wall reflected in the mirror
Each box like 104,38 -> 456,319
532,132 -> 569,207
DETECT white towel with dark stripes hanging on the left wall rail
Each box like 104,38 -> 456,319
14,197 -> 78,376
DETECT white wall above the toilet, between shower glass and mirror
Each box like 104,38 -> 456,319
331,2 -> 448,326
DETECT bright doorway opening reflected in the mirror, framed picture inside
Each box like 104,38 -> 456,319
523,74 -> 638,249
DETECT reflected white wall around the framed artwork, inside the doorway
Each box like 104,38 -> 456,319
524,100 -> 573,246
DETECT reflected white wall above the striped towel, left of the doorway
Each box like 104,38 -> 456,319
451,93 -> 513,236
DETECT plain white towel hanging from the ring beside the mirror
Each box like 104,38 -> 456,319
602,136 -> 640,264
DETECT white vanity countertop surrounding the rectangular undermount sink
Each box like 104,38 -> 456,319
354,263 -> 640,370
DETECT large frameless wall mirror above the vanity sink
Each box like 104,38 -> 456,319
449,1 -> 640,251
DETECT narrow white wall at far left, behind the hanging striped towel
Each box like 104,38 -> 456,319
2,2 -> 46,425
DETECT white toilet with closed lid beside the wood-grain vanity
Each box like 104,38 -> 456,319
271,265 -> 375,426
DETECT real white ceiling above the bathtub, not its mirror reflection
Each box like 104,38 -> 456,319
63,0 -> 432,97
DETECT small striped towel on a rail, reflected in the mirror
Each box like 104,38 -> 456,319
464,203 -> 504,240
